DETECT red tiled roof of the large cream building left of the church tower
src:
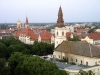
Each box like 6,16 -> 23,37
15,27 -> 52,40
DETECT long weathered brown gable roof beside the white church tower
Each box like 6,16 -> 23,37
55,41 -> 100,57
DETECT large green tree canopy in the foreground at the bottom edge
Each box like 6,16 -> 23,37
9,52 -> 68,75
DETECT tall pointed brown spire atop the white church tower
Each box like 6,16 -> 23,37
56,5 -> 65,28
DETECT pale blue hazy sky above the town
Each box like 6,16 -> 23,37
0,0 -> 100,23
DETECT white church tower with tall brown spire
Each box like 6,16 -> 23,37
55,6 -> 66,48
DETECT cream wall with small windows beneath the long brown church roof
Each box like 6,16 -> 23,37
53,51 -> 100,66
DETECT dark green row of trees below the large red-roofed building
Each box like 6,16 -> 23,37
0,37 -> 54,58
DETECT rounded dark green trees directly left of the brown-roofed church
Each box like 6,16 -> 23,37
32,41 -> 54,55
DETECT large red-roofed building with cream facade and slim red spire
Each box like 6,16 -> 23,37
14,17 -> 54,44
